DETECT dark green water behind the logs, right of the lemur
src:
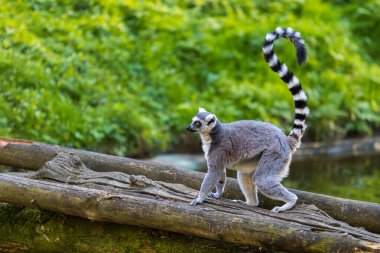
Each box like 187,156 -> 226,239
284,155 -> 380,203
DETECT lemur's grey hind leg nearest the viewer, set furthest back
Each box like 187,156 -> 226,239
253,154 -> 298,213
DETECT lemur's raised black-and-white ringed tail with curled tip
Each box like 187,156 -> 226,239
262,27 -> 309,152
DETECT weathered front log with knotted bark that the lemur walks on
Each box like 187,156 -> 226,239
0,153 -> 380,252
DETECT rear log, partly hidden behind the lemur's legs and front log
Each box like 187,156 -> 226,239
0,138 -> 380,233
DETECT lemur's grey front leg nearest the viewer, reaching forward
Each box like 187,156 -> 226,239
190,162 -> 225,206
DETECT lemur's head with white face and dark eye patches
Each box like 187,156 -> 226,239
186,108 -> 218,133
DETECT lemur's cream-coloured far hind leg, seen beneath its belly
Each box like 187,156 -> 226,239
237,171 -> 259,206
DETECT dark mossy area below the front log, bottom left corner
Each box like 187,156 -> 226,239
0,203 -> 255,253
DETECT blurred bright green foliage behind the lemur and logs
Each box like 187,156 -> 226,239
0,0 -> 380,156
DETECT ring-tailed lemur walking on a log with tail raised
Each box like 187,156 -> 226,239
187,27 -> 309,212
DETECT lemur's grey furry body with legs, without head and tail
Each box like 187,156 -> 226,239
192,116 -> 297,211
